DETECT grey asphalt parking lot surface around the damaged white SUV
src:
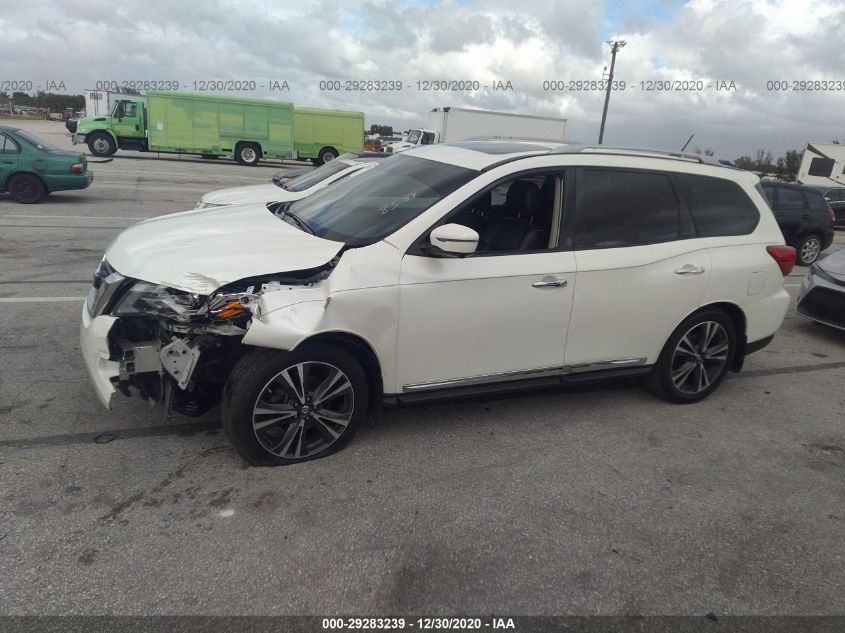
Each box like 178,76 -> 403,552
0,121 -> 845,615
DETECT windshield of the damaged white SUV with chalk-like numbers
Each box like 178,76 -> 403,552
288,155 -> 478,246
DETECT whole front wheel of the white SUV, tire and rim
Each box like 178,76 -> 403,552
221,344 -> 369,466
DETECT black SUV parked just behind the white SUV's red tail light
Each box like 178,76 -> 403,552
760,180 -> 834,266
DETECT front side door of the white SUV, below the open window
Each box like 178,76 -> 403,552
397,172 -> 575,392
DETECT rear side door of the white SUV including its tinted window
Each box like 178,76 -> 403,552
565,167 -> 710,372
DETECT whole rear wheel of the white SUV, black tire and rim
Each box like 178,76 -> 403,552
646,308 -> 736,404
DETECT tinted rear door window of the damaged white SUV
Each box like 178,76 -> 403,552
578,169 -> 680,249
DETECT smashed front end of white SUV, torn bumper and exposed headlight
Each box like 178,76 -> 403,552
80,260 -> 336,416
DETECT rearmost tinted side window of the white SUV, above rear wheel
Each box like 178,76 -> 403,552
677,174 -> 770,237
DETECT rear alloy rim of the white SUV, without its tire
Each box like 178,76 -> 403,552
672,321 -> 730,395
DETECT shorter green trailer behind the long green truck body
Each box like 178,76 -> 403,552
293,106 -> 364,165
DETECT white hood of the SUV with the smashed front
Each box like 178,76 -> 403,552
106,204 -> 343,295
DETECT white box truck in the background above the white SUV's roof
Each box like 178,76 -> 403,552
381,107 -> 566,153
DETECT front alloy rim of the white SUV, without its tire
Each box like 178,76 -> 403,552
252,362 -> 355,459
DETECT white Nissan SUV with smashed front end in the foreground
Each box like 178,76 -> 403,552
81,141 -> 795,465
